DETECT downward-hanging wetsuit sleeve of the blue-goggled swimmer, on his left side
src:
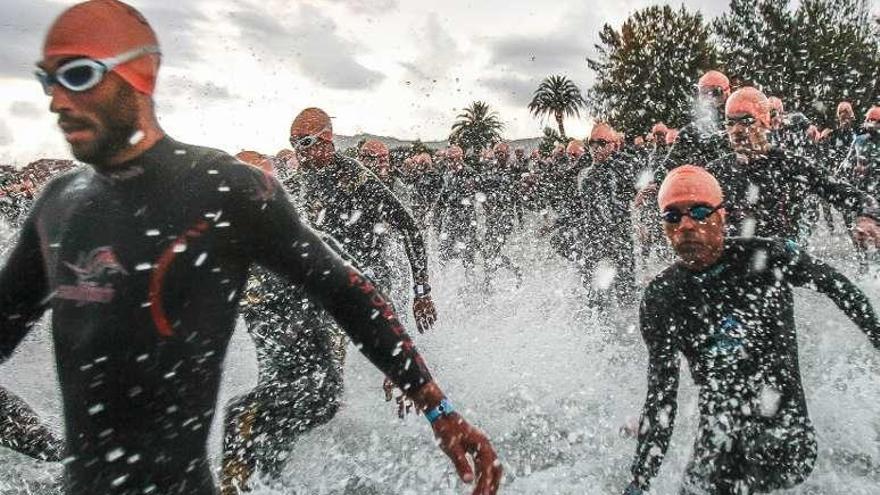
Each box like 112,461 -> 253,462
631,289 -> 679,490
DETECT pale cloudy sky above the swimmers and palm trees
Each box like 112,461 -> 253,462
0,0 -> 727,165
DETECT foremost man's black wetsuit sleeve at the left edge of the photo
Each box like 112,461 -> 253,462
0,219 -> 49,362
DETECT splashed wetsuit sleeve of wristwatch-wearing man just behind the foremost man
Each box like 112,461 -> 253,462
363,178 -> 428,283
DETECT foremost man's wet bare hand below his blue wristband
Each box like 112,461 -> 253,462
433,413 -> 503,495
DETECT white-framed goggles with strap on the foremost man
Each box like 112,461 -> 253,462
34,45 -> 161,96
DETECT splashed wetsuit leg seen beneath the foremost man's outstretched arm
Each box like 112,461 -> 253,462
223,272 -> 347,494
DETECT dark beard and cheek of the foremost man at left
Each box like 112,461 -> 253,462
65,84 -> 138,166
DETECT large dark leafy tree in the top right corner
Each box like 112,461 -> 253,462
714,0 -> 880,126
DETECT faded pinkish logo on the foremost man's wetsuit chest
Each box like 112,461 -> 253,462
55,246 -> 128,304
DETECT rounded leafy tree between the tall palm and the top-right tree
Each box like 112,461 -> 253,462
587,5 -> 718,139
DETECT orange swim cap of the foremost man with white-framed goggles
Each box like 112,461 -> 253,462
43,0 -> 159,95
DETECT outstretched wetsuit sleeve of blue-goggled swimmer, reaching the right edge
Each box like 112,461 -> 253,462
783,242 -> 880,350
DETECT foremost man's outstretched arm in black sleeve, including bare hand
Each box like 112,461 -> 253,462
230,167 -> 502,495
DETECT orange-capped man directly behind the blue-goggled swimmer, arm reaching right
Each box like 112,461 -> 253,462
706,87 -> 880,245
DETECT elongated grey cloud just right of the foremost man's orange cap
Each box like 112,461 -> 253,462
232,5 -> 385,90
